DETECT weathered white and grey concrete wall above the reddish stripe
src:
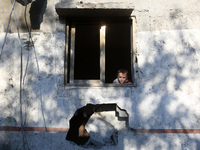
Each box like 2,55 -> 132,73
0,0 -> 200,149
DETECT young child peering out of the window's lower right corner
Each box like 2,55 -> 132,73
113,69 -> 131,84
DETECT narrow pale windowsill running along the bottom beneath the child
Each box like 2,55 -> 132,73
65,83 -> 136,87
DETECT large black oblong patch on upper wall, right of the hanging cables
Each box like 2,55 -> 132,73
29,0 -> 47,30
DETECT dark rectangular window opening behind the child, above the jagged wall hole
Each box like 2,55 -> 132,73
65,18 -> 134,84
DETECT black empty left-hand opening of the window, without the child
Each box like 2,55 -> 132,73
74,24 -> 100,80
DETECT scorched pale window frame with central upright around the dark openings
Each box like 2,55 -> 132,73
64,17 -> 137,86
